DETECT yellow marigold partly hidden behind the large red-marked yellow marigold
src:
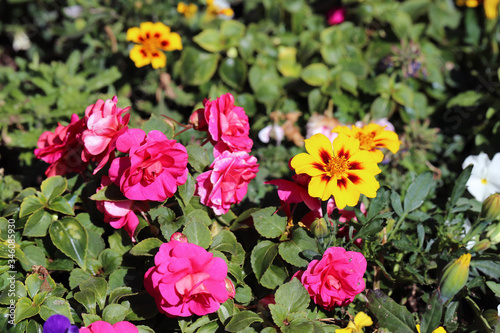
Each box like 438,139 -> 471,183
332,123 -> 401,163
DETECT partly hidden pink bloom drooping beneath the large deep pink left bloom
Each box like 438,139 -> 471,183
96,176 -> 149,242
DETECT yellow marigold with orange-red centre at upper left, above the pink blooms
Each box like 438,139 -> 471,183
127,22 -> 182,68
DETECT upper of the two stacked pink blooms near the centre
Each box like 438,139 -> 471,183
191,93 -> 253,153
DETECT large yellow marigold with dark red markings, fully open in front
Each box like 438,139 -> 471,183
291,133 -> 380,209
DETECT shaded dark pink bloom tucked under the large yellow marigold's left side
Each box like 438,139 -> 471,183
264,174 -> 323,226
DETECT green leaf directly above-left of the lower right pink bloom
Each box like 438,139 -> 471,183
278,228 -> 318,267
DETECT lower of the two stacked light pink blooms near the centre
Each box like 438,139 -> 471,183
196,150 -> 259,215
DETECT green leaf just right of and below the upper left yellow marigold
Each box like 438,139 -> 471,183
180,46 -> 219,86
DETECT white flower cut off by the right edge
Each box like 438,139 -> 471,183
462,153 -> 500,202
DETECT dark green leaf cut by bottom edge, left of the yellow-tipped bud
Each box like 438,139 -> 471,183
366,289 -> 416,333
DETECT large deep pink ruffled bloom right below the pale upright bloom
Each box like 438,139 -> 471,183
109,129 -> 188,201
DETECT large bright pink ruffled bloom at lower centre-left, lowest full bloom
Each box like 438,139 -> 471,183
144,240 -> 234,317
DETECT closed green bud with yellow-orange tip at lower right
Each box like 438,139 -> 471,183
438,253 -> 471,301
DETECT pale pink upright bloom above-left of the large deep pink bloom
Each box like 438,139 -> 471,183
82,96 -> 130,174
